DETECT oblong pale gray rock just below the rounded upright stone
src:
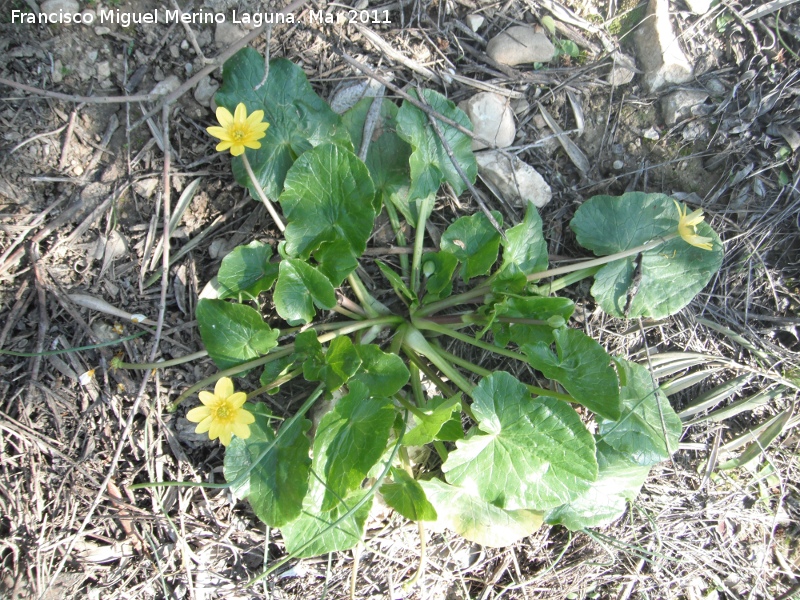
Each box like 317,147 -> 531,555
475,150 -> 553,208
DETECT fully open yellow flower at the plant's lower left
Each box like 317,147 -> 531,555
186,377 -> 256,446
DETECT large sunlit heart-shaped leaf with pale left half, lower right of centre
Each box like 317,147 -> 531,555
434,371 -> 597,511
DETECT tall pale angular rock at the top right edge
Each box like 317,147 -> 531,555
634,0 -> 694,92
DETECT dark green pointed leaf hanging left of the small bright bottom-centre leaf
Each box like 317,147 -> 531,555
314,381 -> 395,510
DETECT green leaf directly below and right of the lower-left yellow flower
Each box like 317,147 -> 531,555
224,404 -> 311,527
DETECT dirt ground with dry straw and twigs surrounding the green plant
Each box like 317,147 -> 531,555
0,0 -> 800,600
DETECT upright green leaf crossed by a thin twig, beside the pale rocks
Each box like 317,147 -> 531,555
397,90 -> 478,199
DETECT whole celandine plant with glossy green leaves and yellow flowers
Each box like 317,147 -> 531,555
130,49 -> 722,580
